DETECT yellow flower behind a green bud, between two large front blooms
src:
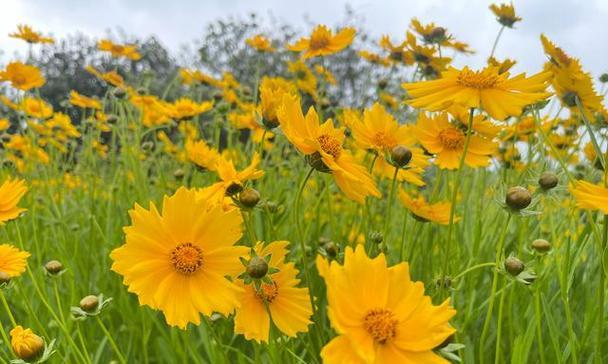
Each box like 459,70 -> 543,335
234,241 -> 312,342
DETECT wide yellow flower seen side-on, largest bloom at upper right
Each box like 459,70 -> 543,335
403,67 -> 551,120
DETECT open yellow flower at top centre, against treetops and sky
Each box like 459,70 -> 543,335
287,25 -> 357,59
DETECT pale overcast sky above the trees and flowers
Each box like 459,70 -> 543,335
0,0 -> 608,76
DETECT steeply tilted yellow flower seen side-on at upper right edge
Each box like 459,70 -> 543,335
540,34 -> 604,121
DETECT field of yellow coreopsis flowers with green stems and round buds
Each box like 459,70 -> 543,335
0,4 -> 608,364
